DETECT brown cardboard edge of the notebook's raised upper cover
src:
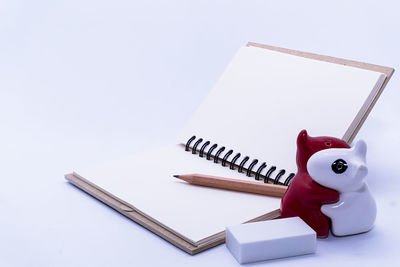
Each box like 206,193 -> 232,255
246,42 -> 394,144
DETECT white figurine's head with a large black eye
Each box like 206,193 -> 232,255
307,140 -> 368,192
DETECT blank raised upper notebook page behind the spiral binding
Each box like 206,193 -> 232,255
178,47 -> 385,179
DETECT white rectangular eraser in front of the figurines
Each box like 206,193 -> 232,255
226,217 -> 317,263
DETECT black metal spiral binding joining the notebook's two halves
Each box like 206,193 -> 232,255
185,135 -> 295,186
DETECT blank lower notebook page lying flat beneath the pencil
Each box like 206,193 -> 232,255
74,145 -> 280,246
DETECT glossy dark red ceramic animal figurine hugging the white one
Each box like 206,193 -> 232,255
281,130 -> 350,237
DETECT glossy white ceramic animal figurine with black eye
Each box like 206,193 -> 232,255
307,140 -> 376,236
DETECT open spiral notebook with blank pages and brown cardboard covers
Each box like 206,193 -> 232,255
66,43 -> 393,254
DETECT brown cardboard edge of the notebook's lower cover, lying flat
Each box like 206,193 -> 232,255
65,173 -> 280,255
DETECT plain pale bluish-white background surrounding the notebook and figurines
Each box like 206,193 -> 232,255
0,0 -> 400,266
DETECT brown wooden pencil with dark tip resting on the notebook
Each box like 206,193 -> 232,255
174,174 -> 287,197
